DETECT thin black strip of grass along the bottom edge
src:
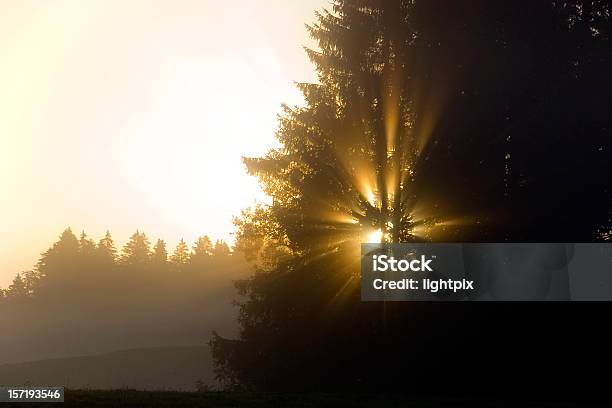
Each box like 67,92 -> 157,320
5,390 -> 609,408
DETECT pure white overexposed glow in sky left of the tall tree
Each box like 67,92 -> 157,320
115,57 -> 283,238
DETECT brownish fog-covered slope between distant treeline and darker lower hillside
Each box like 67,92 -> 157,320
0,279 -> 237,364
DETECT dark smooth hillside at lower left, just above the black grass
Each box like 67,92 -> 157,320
0,346 -> 214,390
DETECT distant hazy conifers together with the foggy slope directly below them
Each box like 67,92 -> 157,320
0,229 -> 249,364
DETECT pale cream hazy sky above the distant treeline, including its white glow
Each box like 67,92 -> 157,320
0,0 -> 328,287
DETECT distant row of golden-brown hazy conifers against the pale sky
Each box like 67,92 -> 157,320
0,228 -> 241,302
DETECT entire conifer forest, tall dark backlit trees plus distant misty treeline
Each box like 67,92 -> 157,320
0,0 -> 612,402
